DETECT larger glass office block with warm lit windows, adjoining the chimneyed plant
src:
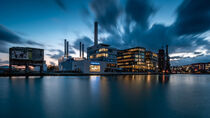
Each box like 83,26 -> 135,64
117,47 -> 147,72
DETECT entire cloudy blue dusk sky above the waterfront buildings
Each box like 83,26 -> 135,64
0,0 -> 210,66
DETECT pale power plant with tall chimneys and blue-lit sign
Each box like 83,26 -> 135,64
58,22 -> 117,73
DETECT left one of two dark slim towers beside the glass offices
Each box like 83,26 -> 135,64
158,49 -> 165,72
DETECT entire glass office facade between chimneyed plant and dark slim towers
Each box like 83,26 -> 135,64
117,47 -> 158,72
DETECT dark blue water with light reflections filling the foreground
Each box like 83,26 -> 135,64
0,75 -> 210,118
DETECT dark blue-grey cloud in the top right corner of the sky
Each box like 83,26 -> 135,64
174,0 -> 210,35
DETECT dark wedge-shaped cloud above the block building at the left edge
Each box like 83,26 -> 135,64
0,25 -> 44,53
